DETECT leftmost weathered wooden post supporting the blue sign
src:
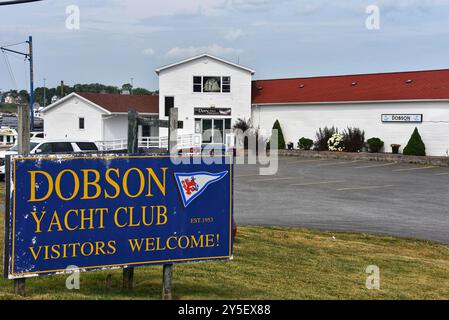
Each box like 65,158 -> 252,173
14,105 -> 30,296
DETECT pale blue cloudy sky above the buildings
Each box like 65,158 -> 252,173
0,0 -> 449,91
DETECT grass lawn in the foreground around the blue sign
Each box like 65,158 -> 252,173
0,183 -> 449,299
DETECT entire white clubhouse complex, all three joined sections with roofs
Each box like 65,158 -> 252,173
43,54 -> 449,156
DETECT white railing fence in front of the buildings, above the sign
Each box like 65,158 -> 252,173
96,134 -> 202,151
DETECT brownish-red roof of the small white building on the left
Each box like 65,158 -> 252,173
42,92 -> 159,114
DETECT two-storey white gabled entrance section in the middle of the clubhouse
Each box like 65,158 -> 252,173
156,54 -> 254,143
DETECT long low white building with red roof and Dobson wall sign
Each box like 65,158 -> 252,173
252,70 -> 449,156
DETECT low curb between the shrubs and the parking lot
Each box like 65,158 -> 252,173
279,150 -> 449,167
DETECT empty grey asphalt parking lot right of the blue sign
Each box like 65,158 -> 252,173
235,158 -> 449,243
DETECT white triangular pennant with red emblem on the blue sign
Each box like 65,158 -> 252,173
175,171 -> 228,208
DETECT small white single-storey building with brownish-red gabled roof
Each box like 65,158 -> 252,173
42,93 -> 159,141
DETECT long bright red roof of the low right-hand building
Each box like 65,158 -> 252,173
252,69 -> 449,104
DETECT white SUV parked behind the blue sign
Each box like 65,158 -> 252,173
0,138 -> 98,180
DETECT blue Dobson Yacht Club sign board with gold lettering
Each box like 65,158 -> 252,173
7,155 -> 233,279
